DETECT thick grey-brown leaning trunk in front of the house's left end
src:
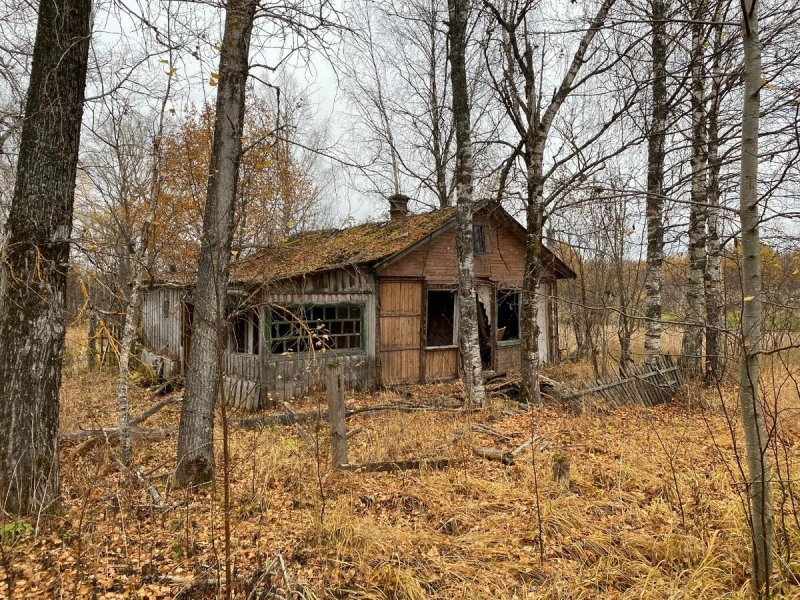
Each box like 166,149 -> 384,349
175,0 -> 257,486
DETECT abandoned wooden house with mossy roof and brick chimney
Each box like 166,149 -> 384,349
141,196 -> 575,409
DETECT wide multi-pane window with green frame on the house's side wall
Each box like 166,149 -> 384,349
269,304 -> 363,354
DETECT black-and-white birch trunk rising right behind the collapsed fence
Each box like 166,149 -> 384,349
644,0 -> 669,363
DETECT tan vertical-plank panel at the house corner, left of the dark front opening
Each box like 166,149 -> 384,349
379,280 -> 422,385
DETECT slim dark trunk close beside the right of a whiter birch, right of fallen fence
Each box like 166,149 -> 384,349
703,8 -> 723,384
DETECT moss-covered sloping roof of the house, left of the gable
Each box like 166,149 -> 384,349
230,207 -> 456,283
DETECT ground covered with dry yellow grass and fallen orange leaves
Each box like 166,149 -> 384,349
0,336 -> 800,599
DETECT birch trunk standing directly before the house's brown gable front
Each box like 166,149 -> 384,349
447,0 -> 486,406
